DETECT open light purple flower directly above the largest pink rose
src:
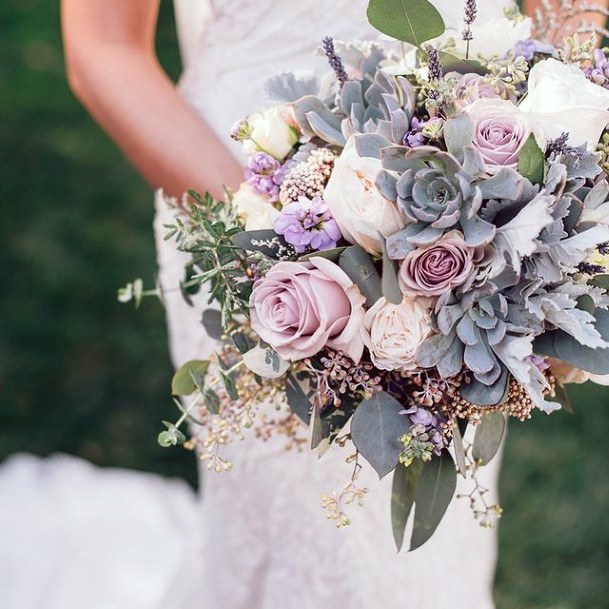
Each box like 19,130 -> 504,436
275,197 -> 342,254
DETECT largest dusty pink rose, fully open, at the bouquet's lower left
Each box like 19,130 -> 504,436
250,257 -> 365,362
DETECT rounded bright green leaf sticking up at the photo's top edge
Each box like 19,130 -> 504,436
367,0 -> 446,48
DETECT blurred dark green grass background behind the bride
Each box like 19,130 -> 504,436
0,0 -> 609,609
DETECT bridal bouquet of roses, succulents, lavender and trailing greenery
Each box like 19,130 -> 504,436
122,0 -> 609,550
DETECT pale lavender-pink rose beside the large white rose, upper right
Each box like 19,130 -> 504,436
465,98 -> 544,174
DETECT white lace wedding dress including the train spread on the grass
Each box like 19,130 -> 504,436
0,0 -> 505,609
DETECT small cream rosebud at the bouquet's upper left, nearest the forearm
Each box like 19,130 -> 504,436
243,106 -> 298,161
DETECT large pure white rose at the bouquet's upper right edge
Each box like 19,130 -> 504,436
519,59 -> 609,149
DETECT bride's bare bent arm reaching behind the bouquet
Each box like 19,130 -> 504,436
62,0 -> 242,197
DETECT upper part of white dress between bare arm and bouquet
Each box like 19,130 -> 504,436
175,0 -> 375,152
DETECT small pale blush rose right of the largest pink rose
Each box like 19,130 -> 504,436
364,298 -> 432,370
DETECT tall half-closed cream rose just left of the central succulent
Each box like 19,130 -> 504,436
323,135 -> 405,254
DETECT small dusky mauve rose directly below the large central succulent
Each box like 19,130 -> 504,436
399,231 -> 485,297
